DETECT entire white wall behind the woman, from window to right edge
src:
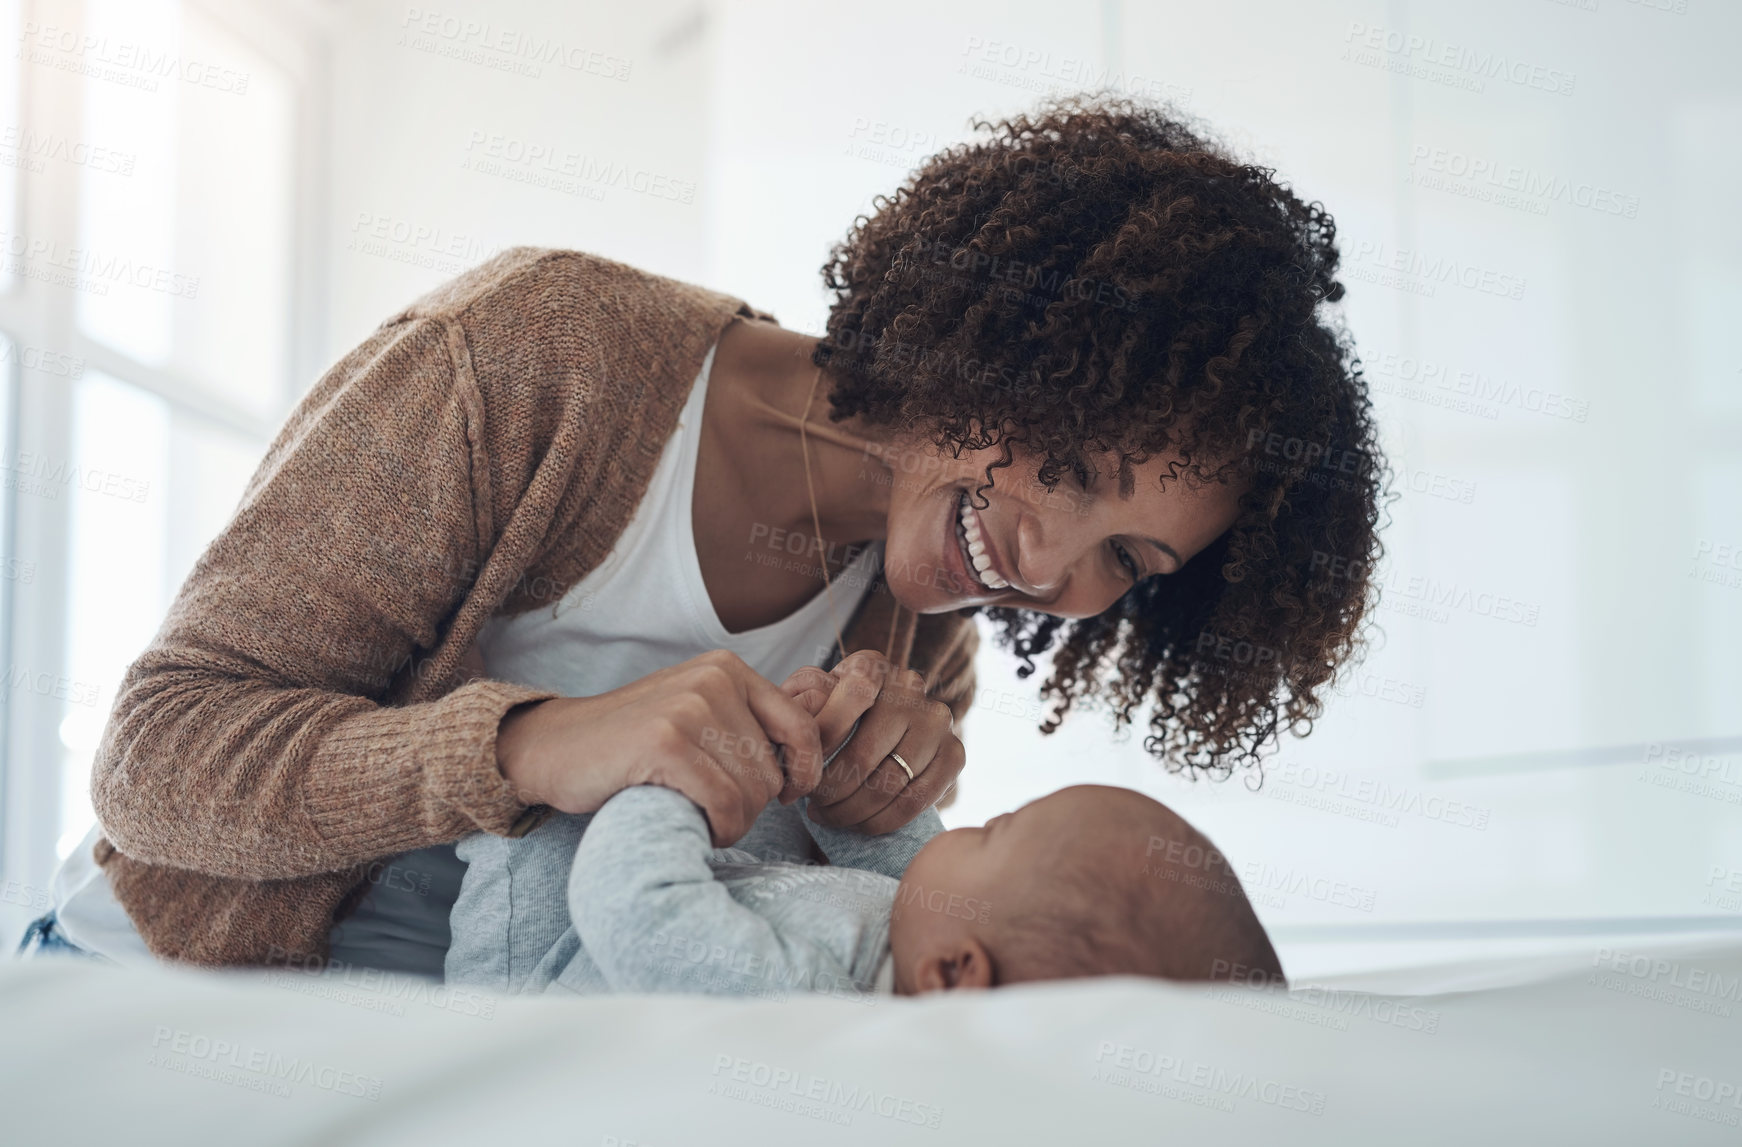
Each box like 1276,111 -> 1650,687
10,0 -> 1742,973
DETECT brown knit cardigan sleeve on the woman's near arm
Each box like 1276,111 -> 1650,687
92,317 -> 552,880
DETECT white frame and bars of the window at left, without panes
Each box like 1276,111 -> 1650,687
0,0 -> 329,931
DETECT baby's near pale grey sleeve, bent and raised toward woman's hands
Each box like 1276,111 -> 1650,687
568,784 -> 850,994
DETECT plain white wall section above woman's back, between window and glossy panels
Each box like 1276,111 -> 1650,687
326,0 -> 711,348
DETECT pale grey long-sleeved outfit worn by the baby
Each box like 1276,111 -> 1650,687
446,786 -> 944,997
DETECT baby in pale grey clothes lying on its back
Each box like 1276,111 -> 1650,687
446,669 -> 1282,999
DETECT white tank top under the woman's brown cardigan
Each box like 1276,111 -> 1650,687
56,341 -> 883,980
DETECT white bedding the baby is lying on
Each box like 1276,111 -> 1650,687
0,947 -> 1742,1147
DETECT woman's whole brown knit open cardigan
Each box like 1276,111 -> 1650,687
92,248 -> 977,966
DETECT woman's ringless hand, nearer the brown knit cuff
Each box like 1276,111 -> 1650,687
496,650 -> 818,847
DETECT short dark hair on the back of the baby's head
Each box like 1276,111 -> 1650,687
988,787 -> 1286,985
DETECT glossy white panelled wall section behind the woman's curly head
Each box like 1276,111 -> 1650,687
689,0 -> 1742,967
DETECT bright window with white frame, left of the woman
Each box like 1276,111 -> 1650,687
0,0 -> 319,934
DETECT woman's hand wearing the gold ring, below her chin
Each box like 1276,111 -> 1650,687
782,650 -> 967,833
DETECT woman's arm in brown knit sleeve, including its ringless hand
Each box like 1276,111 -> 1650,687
92,249 -> 820,880
